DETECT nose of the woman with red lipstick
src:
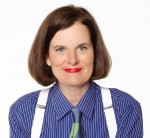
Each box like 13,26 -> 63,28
67,51 -> 79,65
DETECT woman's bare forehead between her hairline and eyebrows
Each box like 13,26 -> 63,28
50,22 -> 91,45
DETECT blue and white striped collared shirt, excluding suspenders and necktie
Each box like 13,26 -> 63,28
9,81 -> 143,138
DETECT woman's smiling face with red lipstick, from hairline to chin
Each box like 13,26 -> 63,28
46,22 -> 94,86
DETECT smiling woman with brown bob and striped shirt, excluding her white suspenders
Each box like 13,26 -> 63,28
9,5 -> 143,138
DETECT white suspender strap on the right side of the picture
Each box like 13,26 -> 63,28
101,87 -> 117,138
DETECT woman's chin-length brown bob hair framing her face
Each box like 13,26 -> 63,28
28,5 -> 111,86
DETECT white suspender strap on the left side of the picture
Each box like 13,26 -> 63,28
31,88 -> 50,138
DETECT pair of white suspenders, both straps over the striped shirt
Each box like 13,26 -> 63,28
31,87 -> 117,138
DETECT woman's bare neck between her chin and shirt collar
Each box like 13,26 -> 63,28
59,83 -> 89,106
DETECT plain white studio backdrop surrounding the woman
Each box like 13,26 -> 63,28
0,0 -> 150,138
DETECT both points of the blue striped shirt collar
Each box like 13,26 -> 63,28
52,81 -> 96,120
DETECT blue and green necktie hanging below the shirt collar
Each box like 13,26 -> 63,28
70,108 -> 85,138
